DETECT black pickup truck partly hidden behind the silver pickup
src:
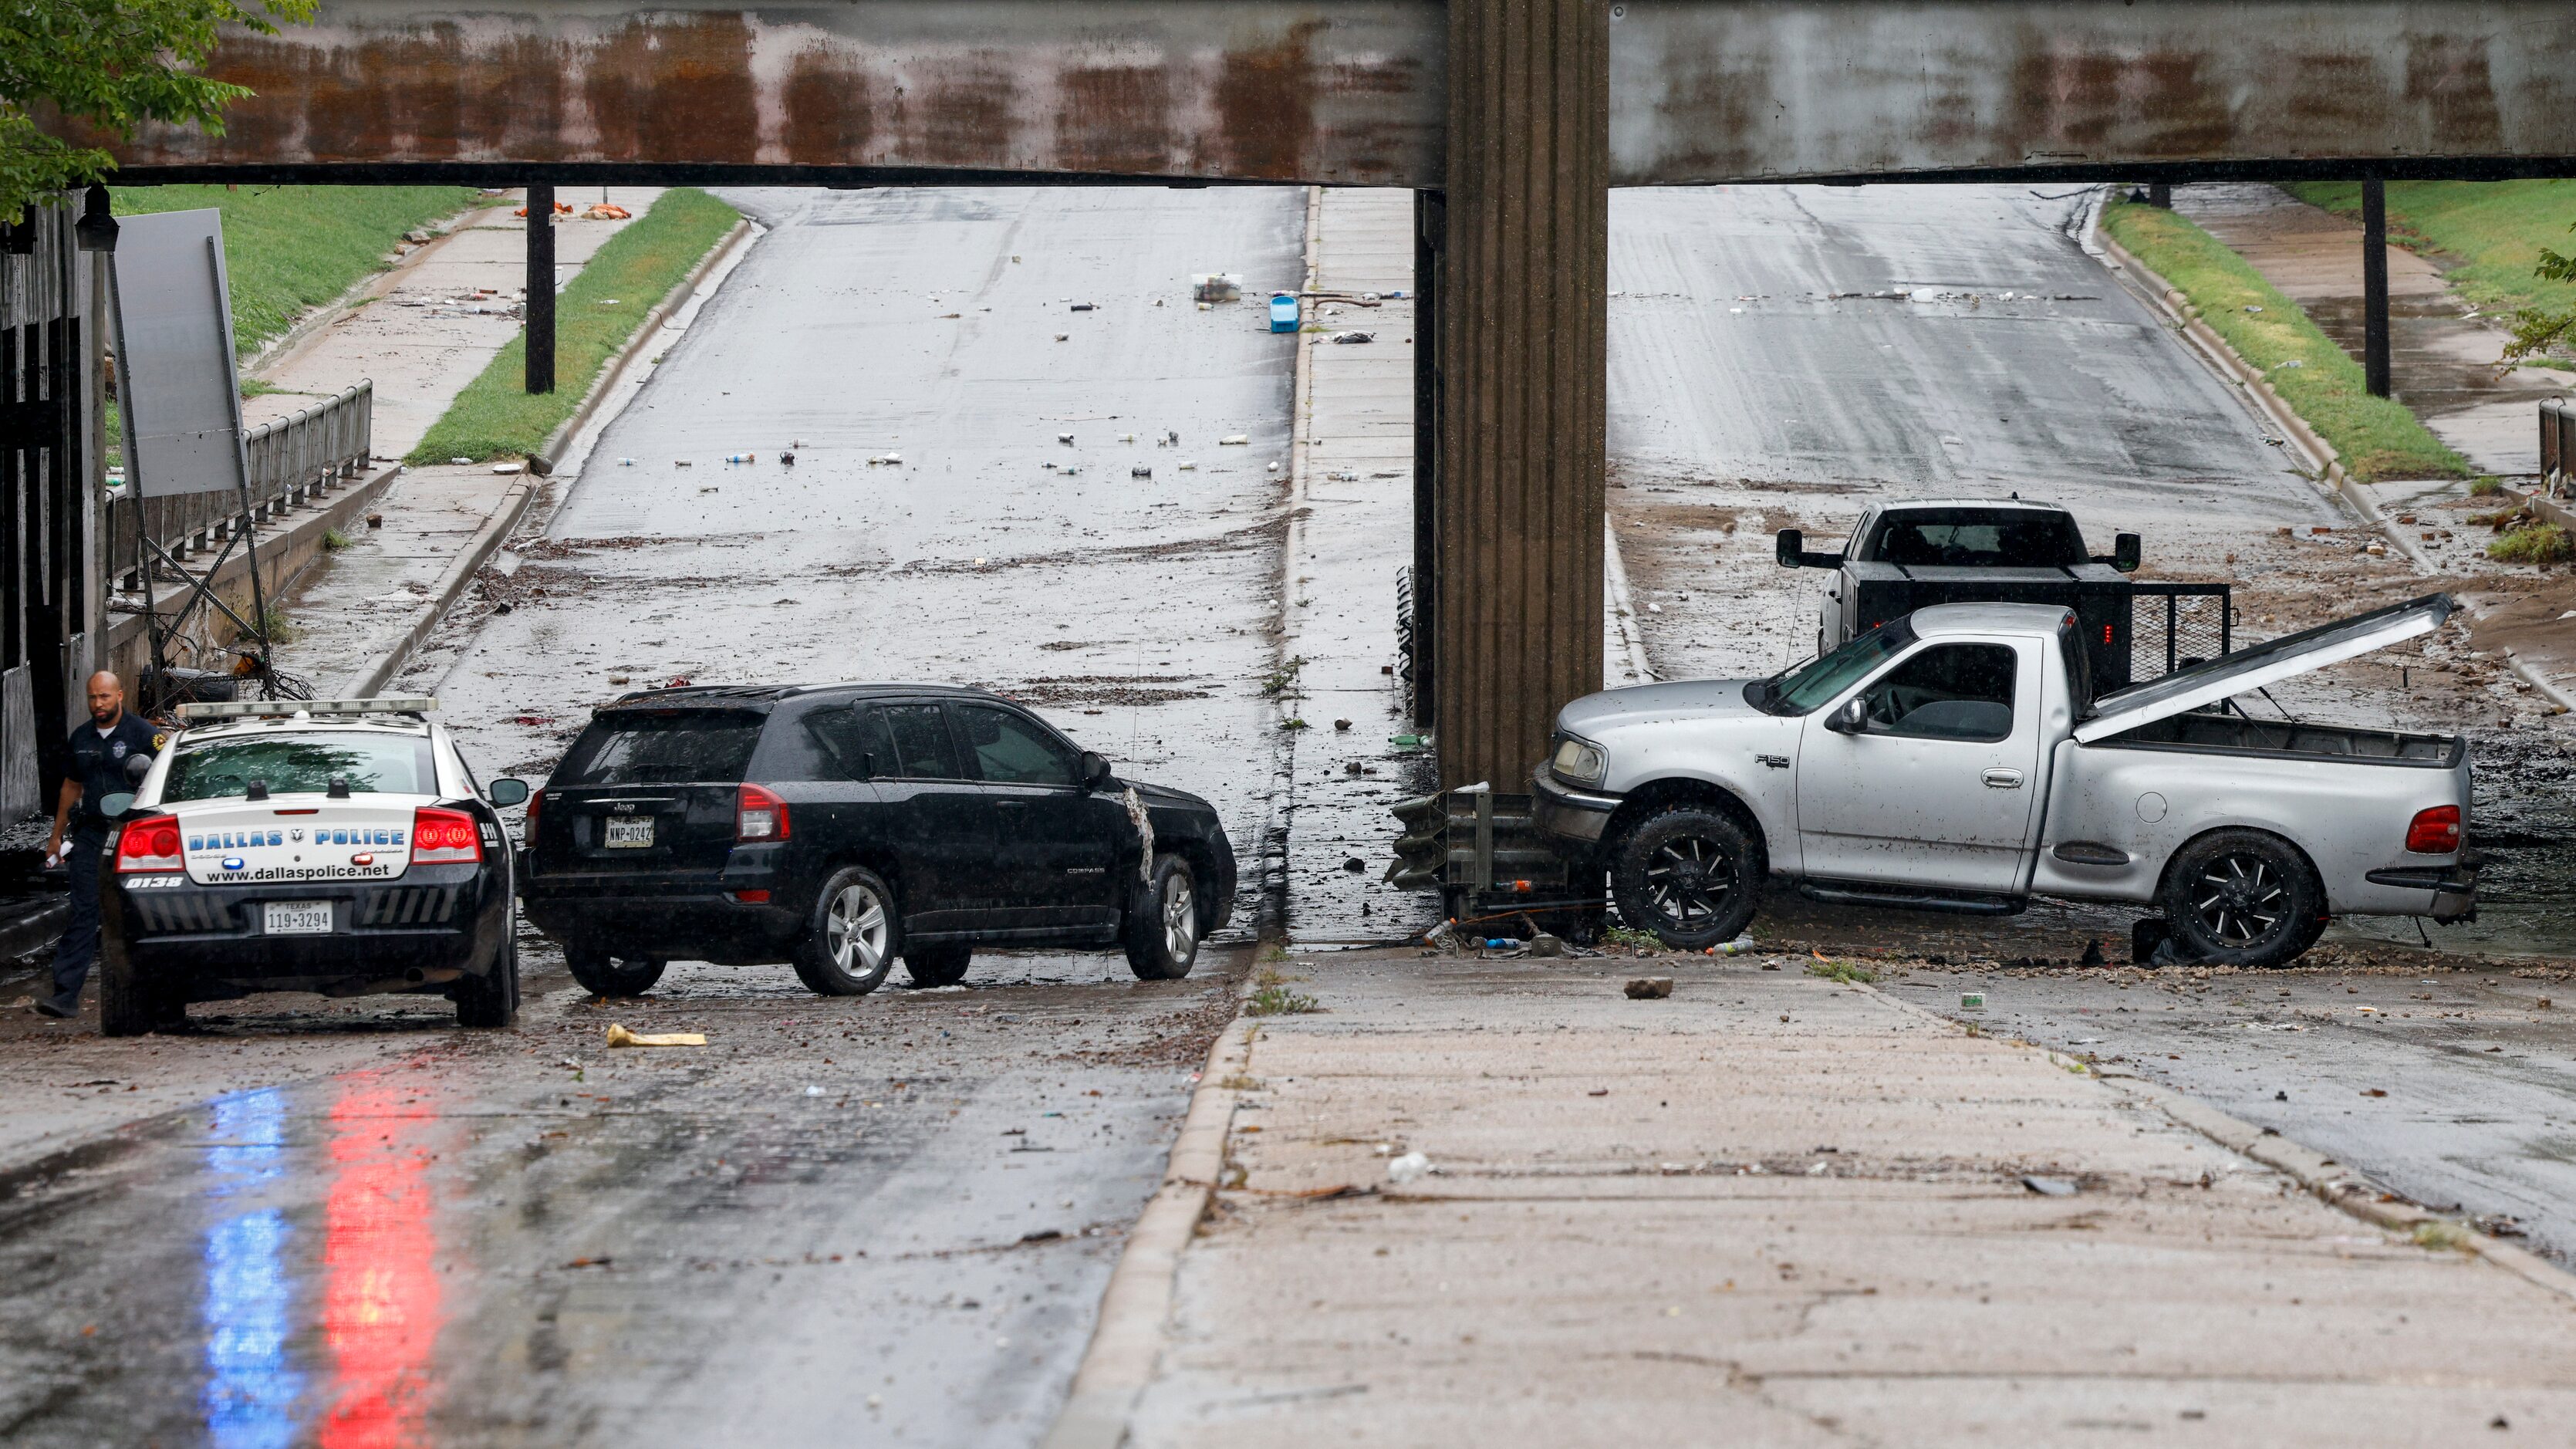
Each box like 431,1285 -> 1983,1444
1780,498 -> 2231,694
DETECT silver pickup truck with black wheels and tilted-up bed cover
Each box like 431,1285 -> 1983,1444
1533,593 -> 2476,967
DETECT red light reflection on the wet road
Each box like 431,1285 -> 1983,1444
317,1072 -> 441,1449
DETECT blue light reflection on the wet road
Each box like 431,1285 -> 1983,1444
204,1088 -> 304,1449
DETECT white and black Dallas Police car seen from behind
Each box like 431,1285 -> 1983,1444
98,699 -> 528,1036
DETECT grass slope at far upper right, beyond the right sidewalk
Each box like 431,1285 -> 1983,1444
2285,178 -> 2576,366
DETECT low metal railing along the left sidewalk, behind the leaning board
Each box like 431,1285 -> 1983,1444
108,382 -> 376,590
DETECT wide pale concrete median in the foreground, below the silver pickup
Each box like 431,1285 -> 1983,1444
1128,951 -> 2576,1449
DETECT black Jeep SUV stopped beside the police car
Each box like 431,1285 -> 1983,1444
520,684 -> 1234,995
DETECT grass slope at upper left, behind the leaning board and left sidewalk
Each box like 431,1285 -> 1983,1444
113,186 -> 500,356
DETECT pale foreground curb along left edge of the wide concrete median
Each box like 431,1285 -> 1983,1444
1038,1015 -> 1257,1449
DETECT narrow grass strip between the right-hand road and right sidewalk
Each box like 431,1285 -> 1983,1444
2102,201 -> 2476,482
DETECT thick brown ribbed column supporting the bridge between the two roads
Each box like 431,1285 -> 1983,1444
1432,0 -> 1610,792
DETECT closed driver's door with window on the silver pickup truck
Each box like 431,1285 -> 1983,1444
1798,640 -> 2048,895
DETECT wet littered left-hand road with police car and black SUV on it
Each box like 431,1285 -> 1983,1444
0,188 -> 1304,1449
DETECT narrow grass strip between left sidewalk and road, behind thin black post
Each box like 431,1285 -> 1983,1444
404,188 -> 742,464
